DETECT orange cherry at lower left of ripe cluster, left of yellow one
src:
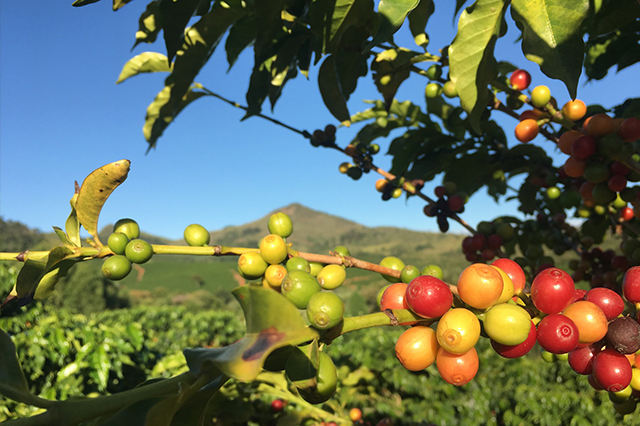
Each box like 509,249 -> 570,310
395,325 -> 440,371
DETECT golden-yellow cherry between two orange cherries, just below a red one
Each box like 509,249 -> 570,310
436,308 -> 480,354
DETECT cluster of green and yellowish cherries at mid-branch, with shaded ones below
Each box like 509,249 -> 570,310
238,212 -> 350,404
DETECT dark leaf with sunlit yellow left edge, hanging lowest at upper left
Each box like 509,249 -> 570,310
142,85 -> 206,147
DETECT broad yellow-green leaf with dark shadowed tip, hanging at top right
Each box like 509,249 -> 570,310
511,0 -> 589,99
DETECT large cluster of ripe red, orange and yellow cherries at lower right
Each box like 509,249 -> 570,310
380,253 -> 640,410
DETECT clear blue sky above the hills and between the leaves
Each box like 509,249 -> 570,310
0,0 -> 638,244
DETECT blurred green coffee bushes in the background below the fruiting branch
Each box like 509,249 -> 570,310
0,307 -> 640,425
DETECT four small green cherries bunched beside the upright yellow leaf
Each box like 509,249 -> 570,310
102,219 -> 153,281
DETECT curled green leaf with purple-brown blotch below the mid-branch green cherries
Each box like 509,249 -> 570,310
184,286 -> 318,381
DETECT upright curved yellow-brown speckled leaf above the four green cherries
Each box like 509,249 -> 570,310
76,160 -> 131,245
